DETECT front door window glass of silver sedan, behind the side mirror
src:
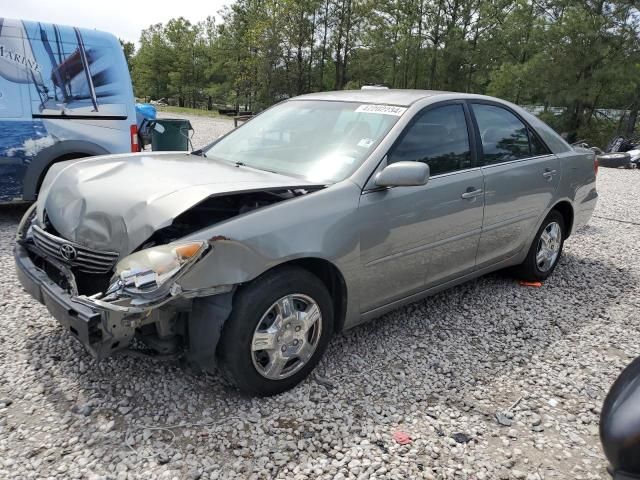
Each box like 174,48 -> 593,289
387,104 -> 471,175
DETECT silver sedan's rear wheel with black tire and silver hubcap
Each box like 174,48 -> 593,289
515,210 -> 565,282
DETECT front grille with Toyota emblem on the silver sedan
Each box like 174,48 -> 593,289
32,225 -> 118,273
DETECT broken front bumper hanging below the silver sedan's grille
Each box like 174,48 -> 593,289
14,243 -> 138,360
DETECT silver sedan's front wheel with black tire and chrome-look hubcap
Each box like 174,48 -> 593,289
218,267 -> 333,396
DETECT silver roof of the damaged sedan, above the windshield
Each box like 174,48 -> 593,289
291,88 -> 458,107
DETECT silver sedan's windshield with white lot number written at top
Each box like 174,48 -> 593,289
204,100 -> 406,183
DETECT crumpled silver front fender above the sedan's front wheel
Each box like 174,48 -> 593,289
178,181 -> 361,326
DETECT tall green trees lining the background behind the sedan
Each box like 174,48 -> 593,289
132,0 -> 640,141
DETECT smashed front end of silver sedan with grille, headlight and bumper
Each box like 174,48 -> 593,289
15,201 -> 234,360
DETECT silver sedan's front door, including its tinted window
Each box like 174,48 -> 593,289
358,102 -> 484,312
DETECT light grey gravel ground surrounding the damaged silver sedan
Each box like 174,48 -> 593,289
0,145 -> 640,480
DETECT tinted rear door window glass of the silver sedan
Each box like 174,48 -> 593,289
473,104 -> 549,165
